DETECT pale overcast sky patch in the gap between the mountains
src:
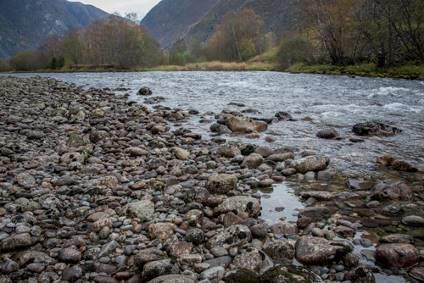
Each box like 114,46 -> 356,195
71,0 -> 160,19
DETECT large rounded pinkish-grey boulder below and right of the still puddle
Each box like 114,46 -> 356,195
296,237 -> 337,265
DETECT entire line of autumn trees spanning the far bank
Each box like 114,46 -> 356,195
0,0 -> 424,71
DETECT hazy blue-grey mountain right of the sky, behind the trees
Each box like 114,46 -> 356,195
141,0 -> 300,48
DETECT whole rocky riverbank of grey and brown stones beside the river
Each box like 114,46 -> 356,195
0,78 -> 424,283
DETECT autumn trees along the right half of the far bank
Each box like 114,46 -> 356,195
169,0 -> 424,68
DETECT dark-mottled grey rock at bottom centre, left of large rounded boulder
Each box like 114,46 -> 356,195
208,225 -> 252,248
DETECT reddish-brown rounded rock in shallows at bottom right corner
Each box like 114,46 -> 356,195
375,243 -> 418,268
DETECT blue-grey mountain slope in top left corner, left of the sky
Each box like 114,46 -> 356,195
0,0 -> 108,58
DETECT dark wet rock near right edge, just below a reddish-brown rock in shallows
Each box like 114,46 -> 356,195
370,182 -> 413,200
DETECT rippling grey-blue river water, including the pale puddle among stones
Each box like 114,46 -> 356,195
4,72 -> 424,282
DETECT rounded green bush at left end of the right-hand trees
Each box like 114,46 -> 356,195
277,36 -> 314,68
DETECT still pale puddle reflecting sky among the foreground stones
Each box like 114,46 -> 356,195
261,182 -> 304,224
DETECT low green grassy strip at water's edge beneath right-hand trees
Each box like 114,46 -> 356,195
286,64 -> 424,80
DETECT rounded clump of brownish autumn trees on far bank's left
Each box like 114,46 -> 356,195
0,16 -> 162,71
